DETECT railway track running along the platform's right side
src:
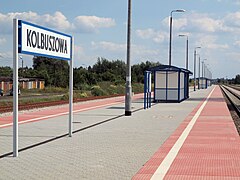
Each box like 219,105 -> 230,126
220,85 -> 240,117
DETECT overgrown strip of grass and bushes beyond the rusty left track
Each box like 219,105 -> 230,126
0,82 -> 144,106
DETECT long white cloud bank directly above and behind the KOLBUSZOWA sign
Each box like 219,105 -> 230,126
0,11 -> 115,34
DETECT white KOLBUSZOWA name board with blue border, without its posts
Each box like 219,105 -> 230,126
18,20 -> 72,60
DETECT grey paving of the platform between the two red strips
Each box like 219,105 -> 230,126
0,88 -> 211,180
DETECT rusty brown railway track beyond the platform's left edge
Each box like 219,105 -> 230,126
0,95 -> 122,113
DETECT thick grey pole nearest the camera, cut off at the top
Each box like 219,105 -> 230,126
125,0 -> 132,116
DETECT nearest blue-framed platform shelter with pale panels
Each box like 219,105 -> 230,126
150,65 -> 192,102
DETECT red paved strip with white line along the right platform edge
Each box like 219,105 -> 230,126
133,87 -> 240,180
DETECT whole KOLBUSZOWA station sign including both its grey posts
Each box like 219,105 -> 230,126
13,19 -> 74,157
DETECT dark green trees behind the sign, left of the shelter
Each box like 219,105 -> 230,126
0,56 -> 160,89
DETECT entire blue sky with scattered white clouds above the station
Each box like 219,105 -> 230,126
0,0 -> 240,78
